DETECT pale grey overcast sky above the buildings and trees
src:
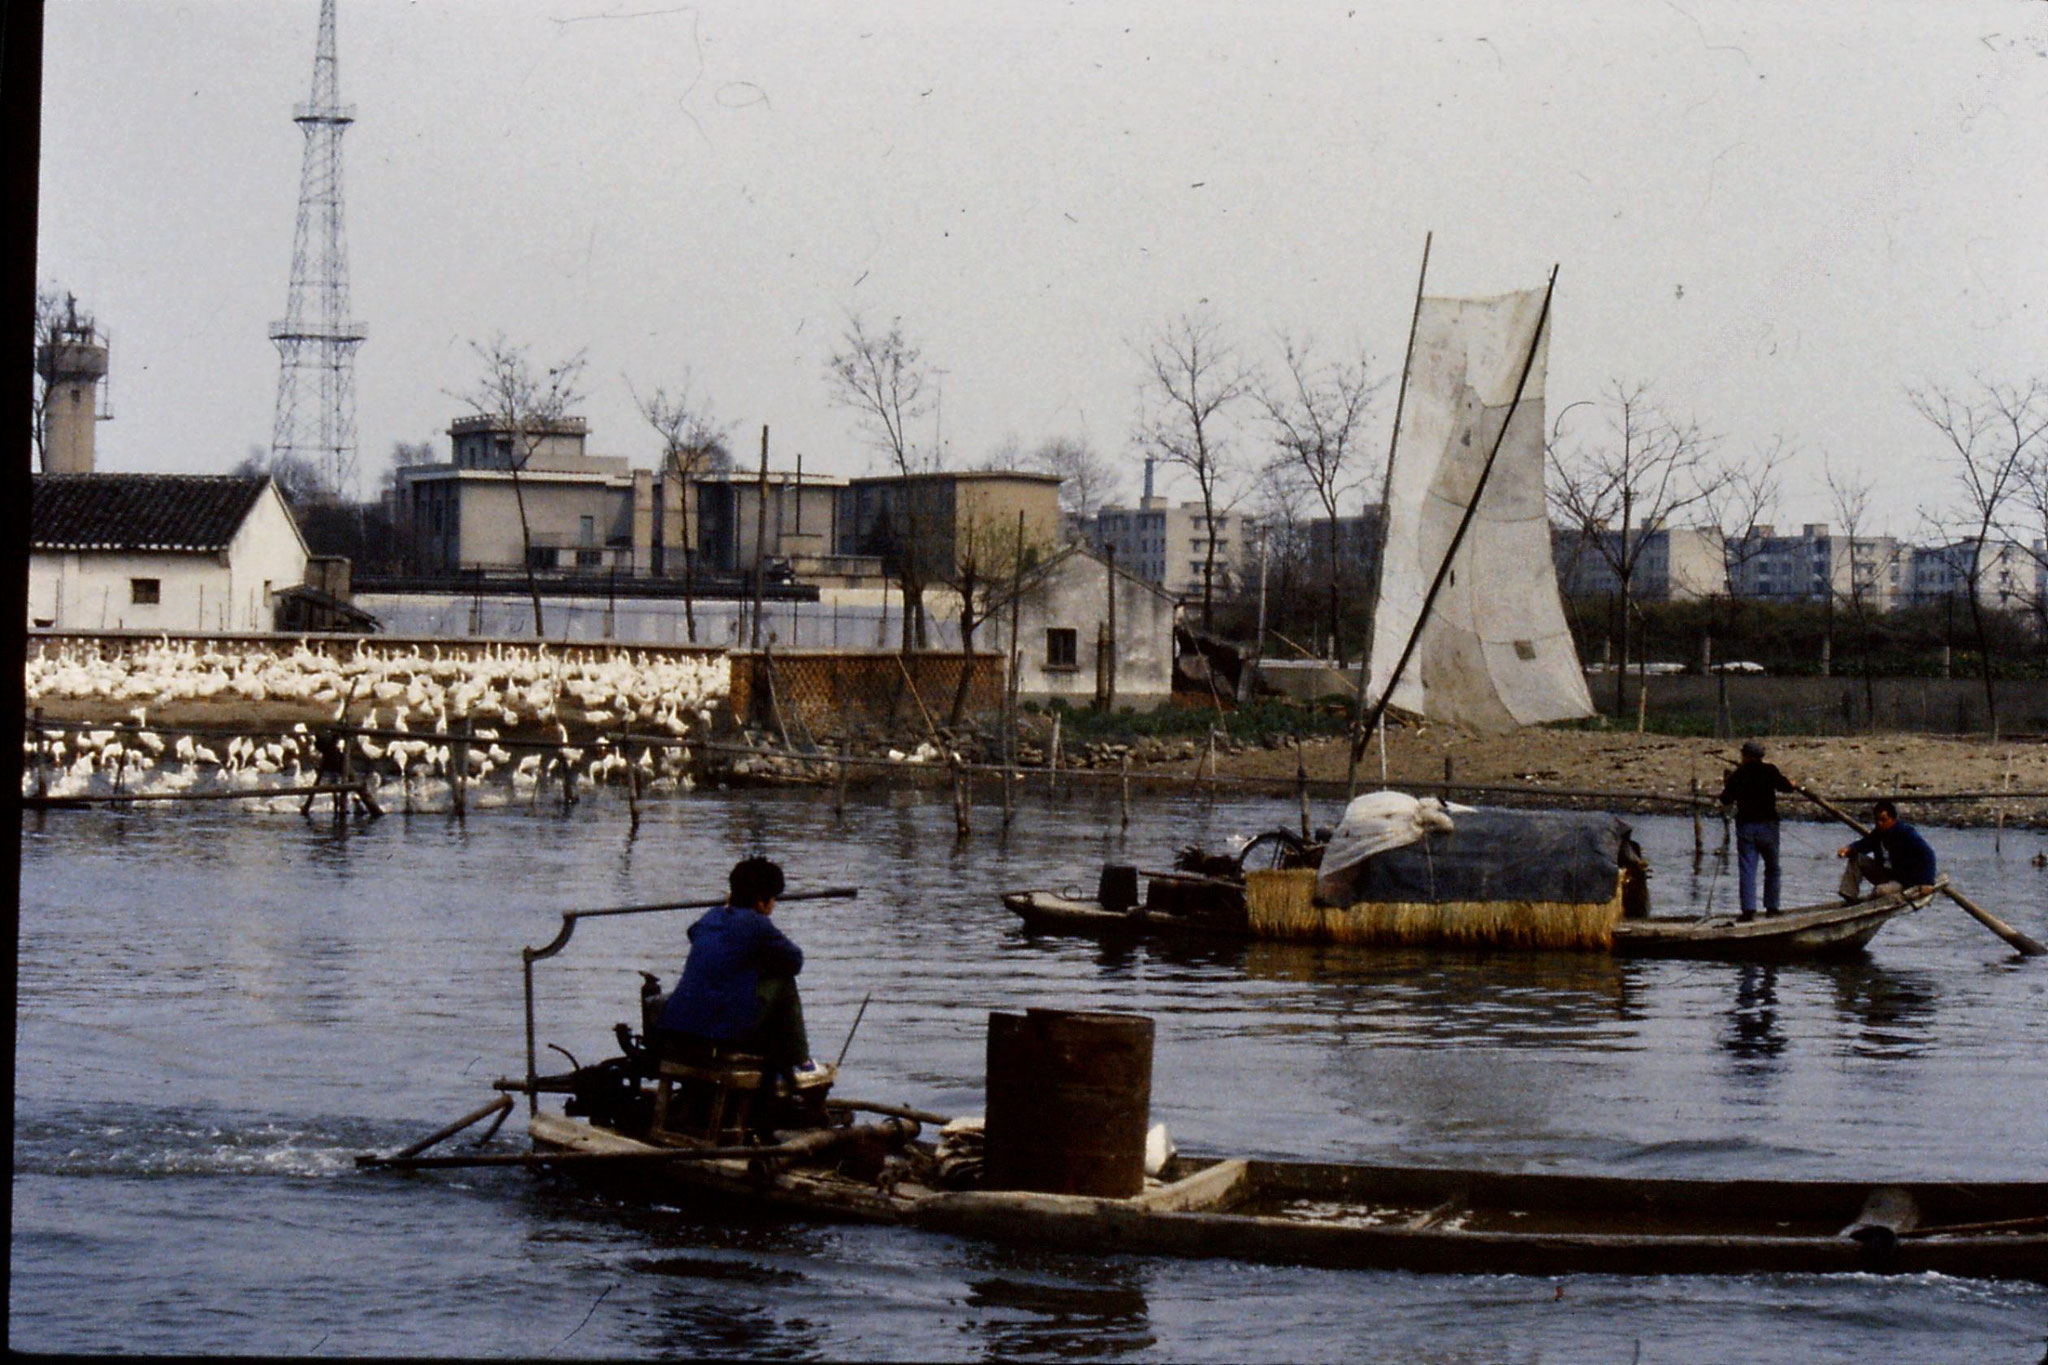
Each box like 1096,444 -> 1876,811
39,0 -> 2048,534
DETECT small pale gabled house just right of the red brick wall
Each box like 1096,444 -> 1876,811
989,544 -> 1176,710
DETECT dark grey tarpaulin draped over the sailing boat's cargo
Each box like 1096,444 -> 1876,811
1317,808 -> 1628,905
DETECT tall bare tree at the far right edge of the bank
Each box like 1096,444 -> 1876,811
1907,379 -> 2048,735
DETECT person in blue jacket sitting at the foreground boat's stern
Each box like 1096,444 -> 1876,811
649,857 -> 811,1078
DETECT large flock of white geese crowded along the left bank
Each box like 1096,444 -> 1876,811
23,639 -> 731,804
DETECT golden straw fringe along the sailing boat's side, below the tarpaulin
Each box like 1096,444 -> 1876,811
1245,868 -> 1622,952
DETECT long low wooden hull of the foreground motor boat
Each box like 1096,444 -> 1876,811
530,1113 -> 2048,1281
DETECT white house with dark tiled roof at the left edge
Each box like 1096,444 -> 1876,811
29,475 -> 307,630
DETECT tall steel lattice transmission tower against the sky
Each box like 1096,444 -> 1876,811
270,0 -> 362,495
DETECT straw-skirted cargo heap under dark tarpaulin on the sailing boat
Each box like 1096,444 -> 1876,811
1245,794 -> 1634,950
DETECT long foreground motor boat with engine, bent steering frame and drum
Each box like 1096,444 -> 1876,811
368,890 -> 2048,1283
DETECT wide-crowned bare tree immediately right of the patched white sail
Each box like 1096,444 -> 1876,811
1548,379 -> 1729,712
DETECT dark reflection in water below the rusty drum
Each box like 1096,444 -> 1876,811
967,1265 -> 1155,1361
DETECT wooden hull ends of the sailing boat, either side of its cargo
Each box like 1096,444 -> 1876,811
1004,878 -> 1946,962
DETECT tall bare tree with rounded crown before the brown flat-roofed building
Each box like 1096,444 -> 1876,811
825,313 -> 938,653
